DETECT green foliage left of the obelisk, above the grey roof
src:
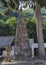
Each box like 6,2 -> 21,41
0,17 -> 17,36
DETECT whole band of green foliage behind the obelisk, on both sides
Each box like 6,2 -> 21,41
0,17 -> 46,42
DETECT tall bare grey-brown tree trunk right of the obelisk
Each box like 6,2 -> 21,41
35,1 -> 45,59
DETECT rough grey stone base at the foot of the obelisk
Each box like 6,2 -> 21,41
14,48 -> 32,61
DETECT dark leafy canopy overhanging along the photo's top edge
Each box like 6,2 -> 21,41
0,0 -> 46,10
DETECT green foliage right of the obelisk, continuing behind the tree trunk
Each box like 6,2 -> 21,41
25,17 -> 46,42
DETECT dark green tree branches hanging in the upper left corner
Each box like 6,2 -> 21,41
0,0 -> 19,15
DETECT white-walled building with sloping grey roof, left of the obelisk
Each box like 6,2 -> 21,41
0,36 -> 15,57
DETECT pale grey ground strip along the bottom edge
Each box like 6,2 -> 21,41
0,59 -> 46,65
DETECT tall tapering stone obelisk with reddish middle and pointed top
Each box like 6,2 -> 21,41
15,8 -> 31,56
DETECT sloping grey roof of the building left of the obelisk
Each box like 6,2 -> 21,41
0,36 -> 15,48
